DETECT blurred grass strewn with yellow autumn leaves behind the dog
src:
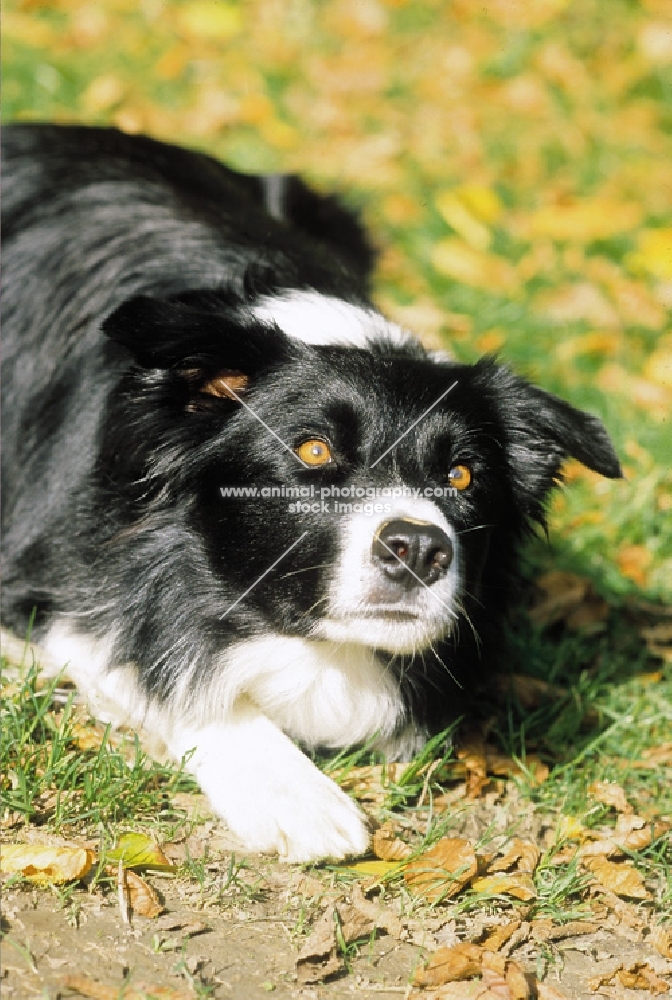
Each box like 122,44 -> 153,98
3,0 -> 672,597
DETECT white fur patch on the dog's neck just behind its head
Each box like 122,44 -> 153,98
252,291 -> 414,348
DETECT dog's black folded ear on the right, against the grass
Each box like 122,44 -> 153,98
477,359 -> 623,516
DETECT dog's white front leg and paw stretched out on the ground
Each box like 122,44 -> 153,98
171,700 -> 369,861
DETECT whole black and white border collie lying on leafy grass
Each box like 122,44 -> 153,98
3,125 -> 620,860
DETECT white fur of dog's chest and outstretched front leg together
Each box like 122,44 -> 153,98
44,623 -> 404,861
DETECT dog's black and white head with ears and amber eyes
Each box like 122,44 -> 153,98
106,294 -> 620,653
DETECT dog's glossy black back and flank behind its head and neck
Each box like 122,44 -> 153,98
2,125 -> 373,630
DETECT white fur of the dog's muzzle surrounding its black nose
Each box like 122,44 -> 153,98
316,497 -> 460,653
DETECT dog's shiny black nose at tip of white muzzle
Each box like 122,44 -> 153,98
371,518 -> 453,590
